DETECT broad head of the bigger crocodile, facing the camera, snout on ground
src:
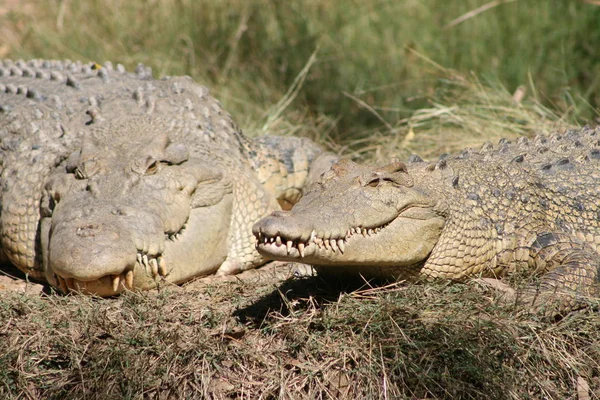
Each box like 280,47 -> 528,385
40,121 -> 232,296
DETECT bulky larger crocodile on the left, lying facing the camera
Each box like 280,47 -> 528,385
0,60 -> 333,296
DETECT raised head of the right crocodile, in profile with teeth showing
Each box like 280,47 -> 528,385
253,160 -> 444,278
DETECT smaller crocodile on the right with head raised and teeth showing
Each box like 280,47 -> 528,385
253,126 -> 600,313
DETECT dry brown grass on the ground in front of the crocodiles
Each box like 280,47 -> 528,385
0,270 -> 600,399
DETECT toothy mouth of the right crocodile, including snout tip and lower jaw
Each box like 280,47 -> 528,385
253,204 -> 444,267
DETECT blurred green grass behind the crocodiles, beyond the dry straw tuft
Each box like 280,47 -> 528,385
0,0 -> 600,143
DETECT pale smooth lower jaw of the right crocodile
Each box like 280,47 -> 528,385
256,209 -> 444,266
